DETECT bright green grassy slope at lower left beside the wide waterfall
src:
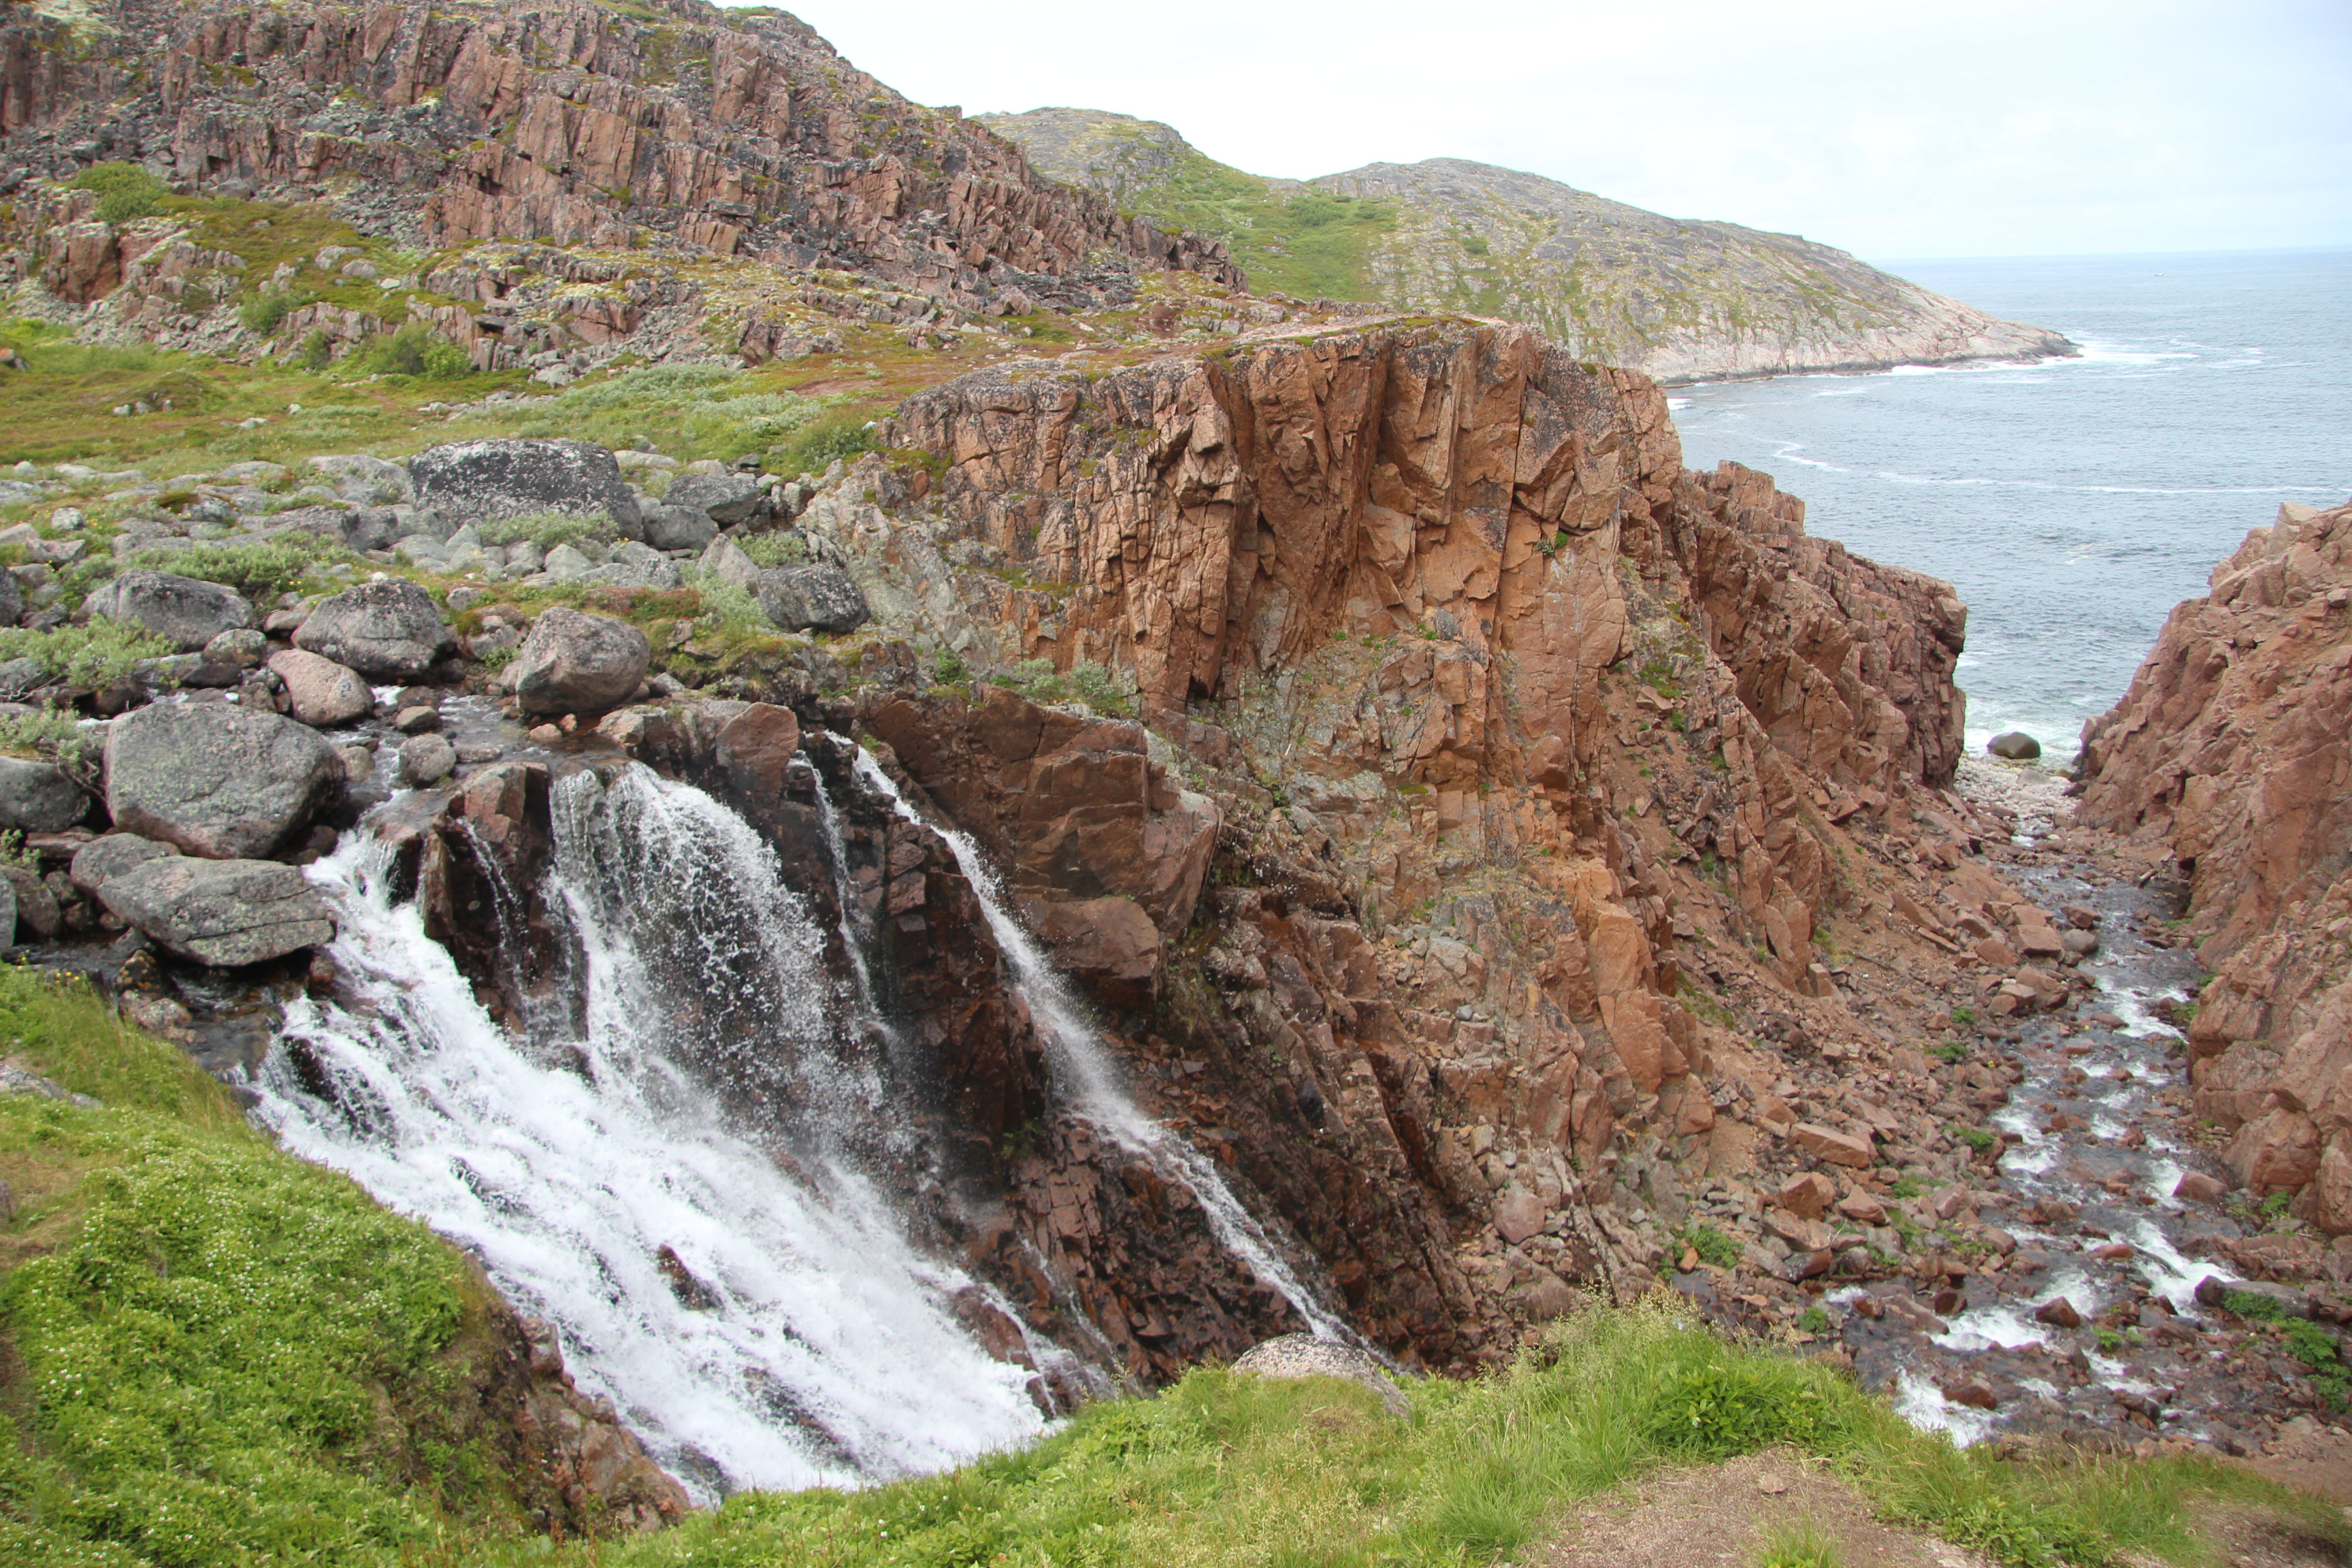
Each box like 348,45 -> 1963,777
0,968 -> 559,1568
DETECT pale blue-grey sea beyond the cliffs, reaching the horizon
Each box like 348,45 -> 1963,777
1672,249 -> 2352,762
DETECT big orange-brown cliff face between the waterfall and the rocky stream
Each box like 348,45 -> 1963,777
734,325 -> 2023,1363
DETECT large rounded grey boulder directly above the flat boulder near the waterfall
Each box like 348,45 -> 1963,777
106,700 -> 344,860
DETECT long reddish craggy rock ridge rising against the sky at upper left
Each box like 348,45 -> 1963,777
0,0 -> 1239,308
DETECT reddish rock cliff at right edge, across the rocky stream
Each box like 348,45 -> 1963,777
2079,506 -> 2352,1234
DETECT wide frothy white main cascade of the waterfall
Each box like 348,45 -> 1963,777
257,766 -> 1044,1500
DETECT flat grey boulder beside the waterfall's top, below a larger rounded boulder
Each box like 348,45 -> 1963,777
99,855 -> 334,968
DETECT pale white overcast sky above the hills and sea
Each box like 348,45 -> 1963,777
762,0 -> 2352,261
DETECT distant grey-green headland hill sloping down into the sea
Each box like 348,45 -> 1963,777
979,108 -> 2077,381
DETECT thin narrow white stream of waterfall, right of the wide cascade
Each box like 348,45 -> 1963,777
854,747 -> 1360,1345
